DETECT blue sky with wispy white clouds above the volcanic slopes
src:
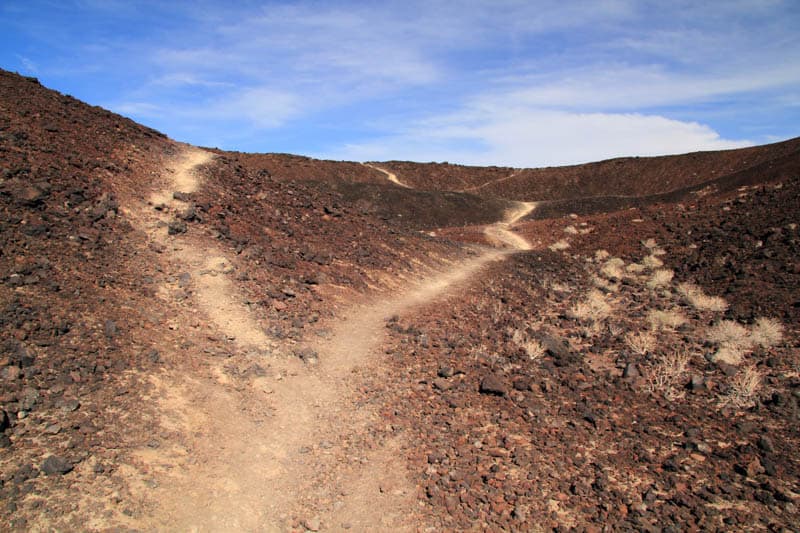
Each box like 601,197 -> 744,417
0,0 -> 800,167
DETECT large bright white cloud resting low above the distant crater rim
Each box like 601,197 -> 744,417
320,108 -> 751,167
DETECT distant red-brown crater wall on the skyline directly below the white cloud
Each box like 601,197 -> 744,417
382,139 -> 800,201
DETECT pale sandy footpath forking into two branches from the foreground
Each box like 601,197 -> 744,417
123,148 -> 535,531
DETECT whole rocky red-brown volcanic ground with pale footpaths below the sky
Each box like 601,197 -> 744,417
0,71 -> 800,531
